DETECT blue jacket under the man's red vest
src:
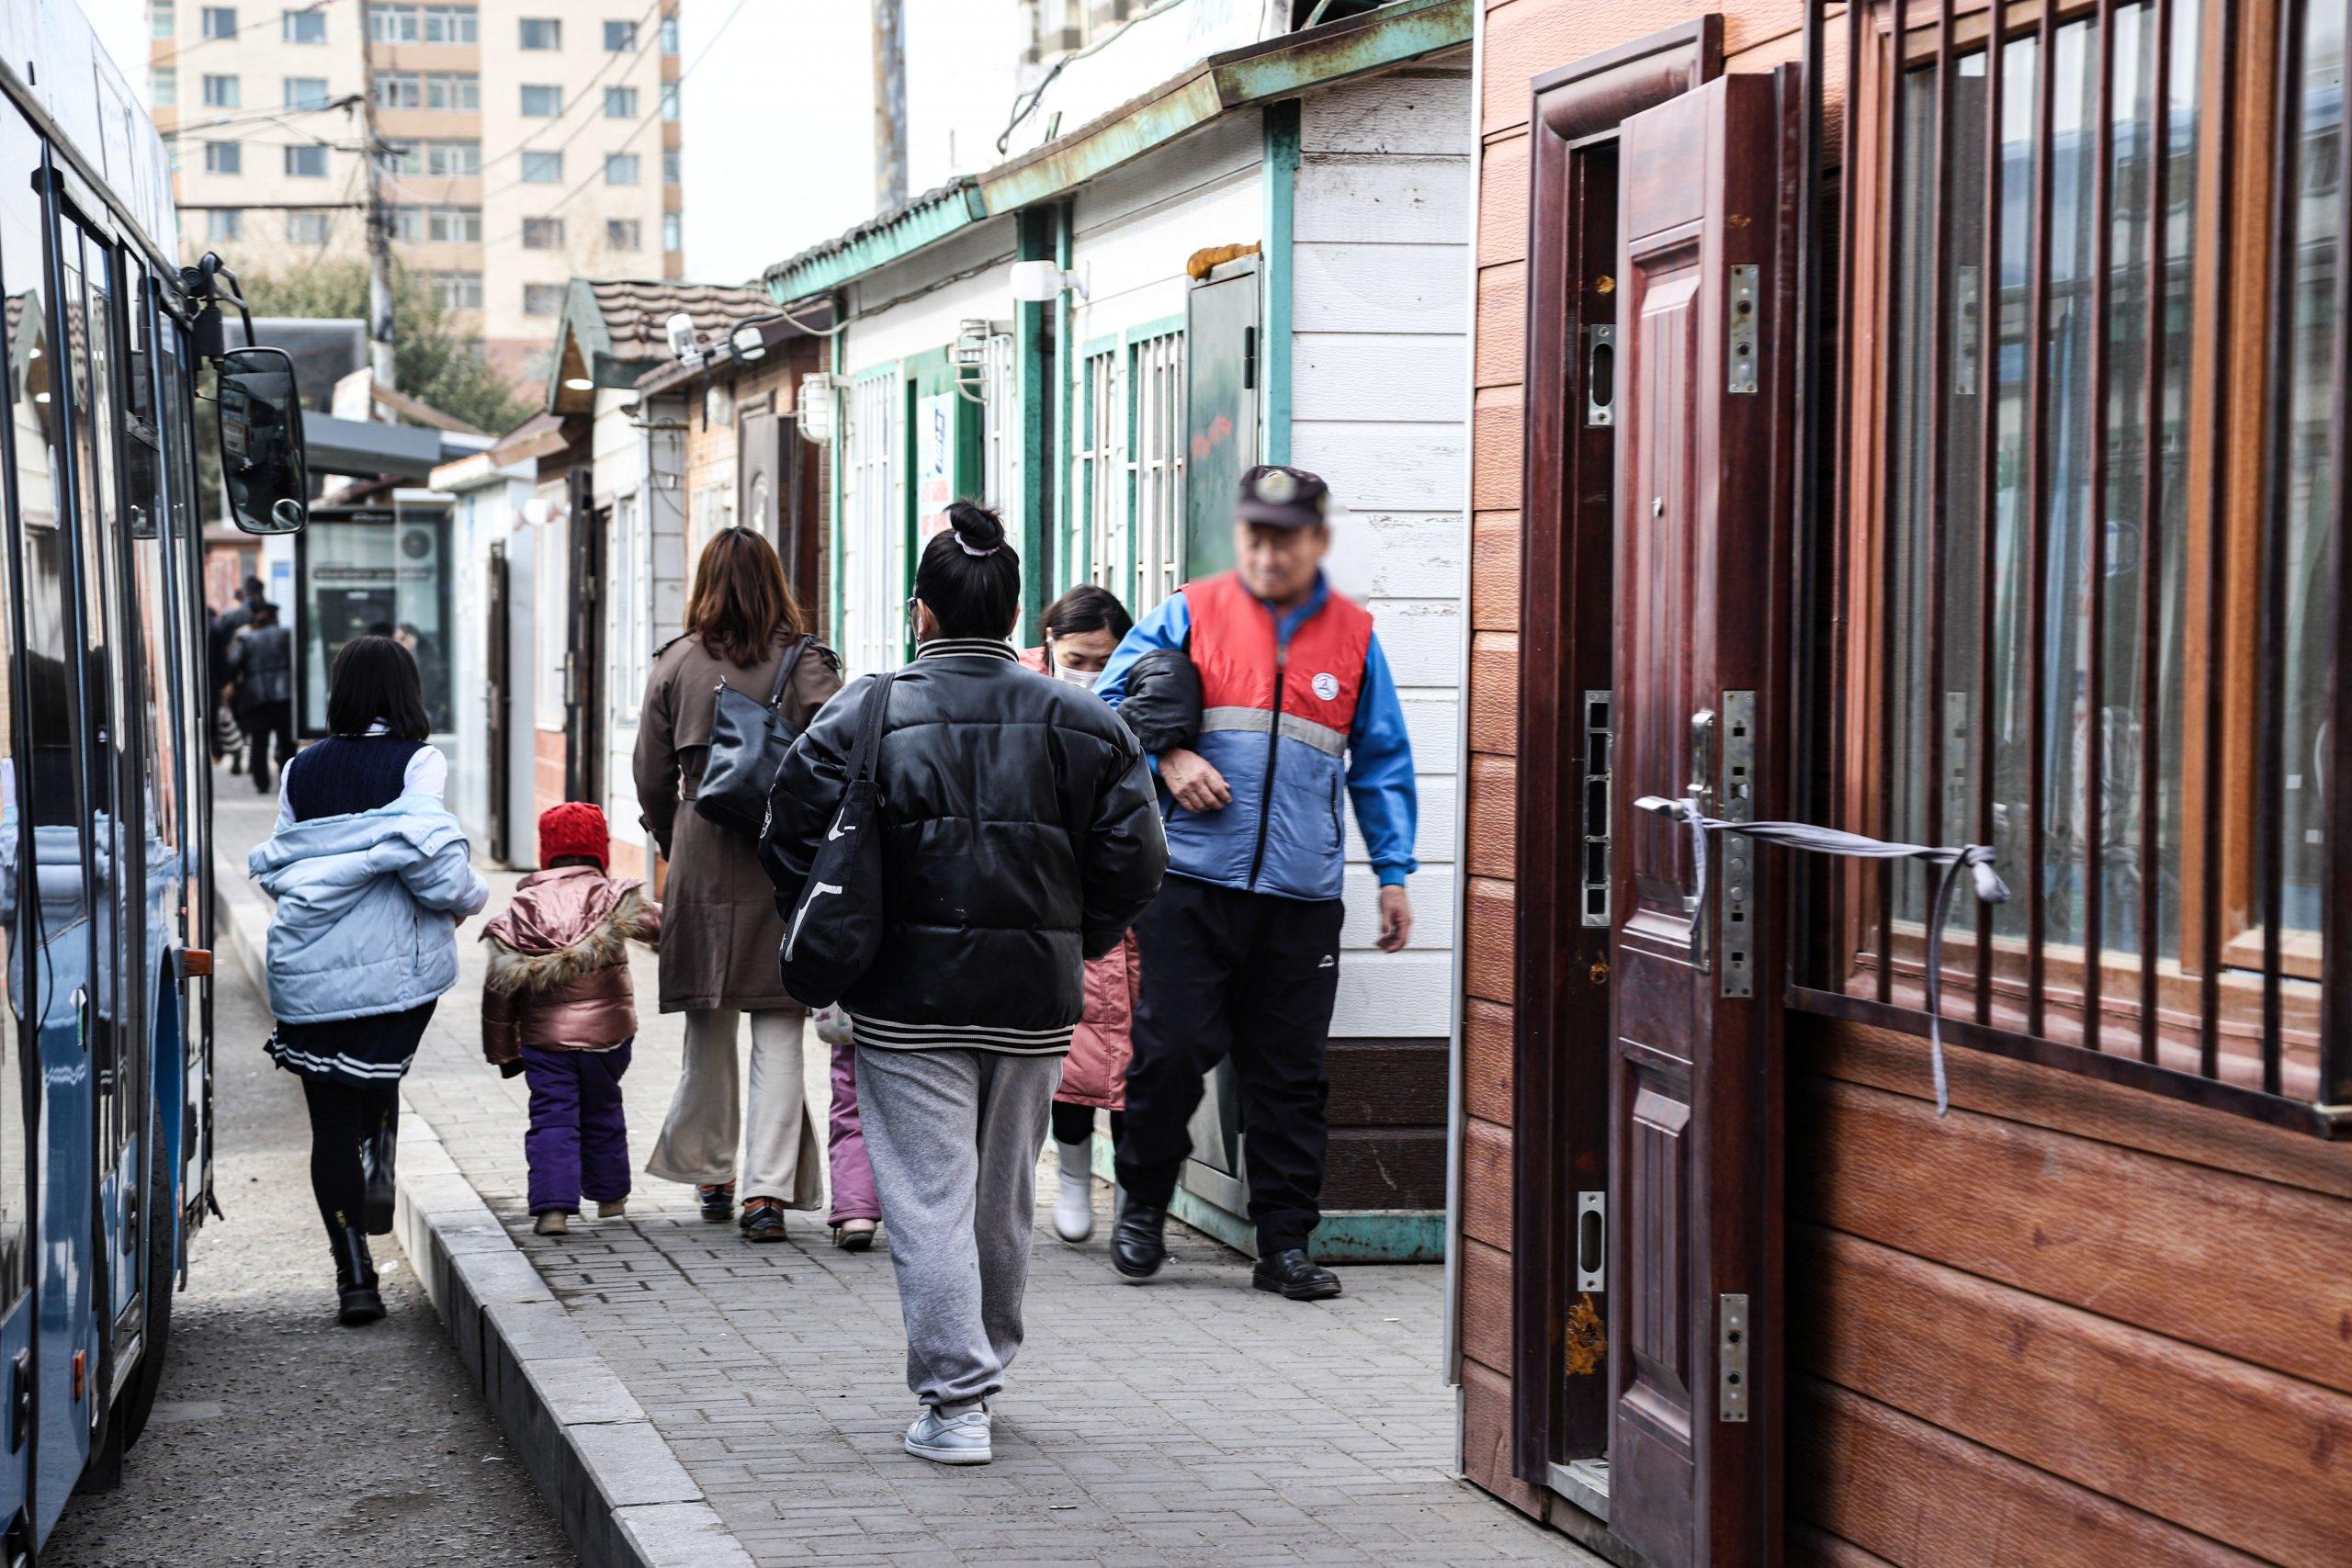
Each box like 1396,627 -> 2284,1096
1093,579 -> 1419,898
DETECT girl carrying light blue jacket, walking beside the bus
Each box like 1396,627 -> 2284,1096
247,637 -> 489,1325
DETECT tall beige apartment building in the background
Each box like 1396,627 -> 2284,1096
148,0 -> 684,386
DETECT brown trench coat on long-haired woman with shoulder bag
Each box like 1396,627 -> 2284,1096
635,635 -> 842,1013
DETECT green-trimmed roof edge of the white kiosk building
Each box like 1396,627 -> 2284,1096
762,0 -> 1477,306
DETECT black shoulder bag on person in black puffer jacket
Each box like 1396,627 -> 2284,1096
776,672 -> 894,1009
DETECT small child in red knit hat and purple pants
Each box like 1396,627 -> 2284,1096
482,802 -> 661,1236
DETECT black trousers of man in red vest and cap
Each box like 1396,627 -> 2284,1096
1120,877 -> 1340,1253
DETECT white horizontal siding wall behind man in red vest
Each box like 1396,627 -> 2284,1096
1291,68 -> 1475,1037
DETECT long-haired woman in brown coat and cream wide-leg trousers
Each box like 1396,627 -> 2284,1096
635,529 -> 842,1241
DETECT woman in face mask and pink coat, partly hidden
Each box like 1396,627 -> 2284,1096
1021,583 -> 1138,1244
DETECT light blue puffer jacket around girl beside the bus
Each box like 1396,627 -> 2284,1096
244,795 -> 489,1022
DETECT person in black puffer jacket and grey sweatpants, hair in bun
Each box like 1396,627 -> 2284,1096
769,501 -> 1167,1464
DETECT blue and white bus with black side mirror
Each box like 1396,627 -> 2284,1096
0,0 -> 308,1565
